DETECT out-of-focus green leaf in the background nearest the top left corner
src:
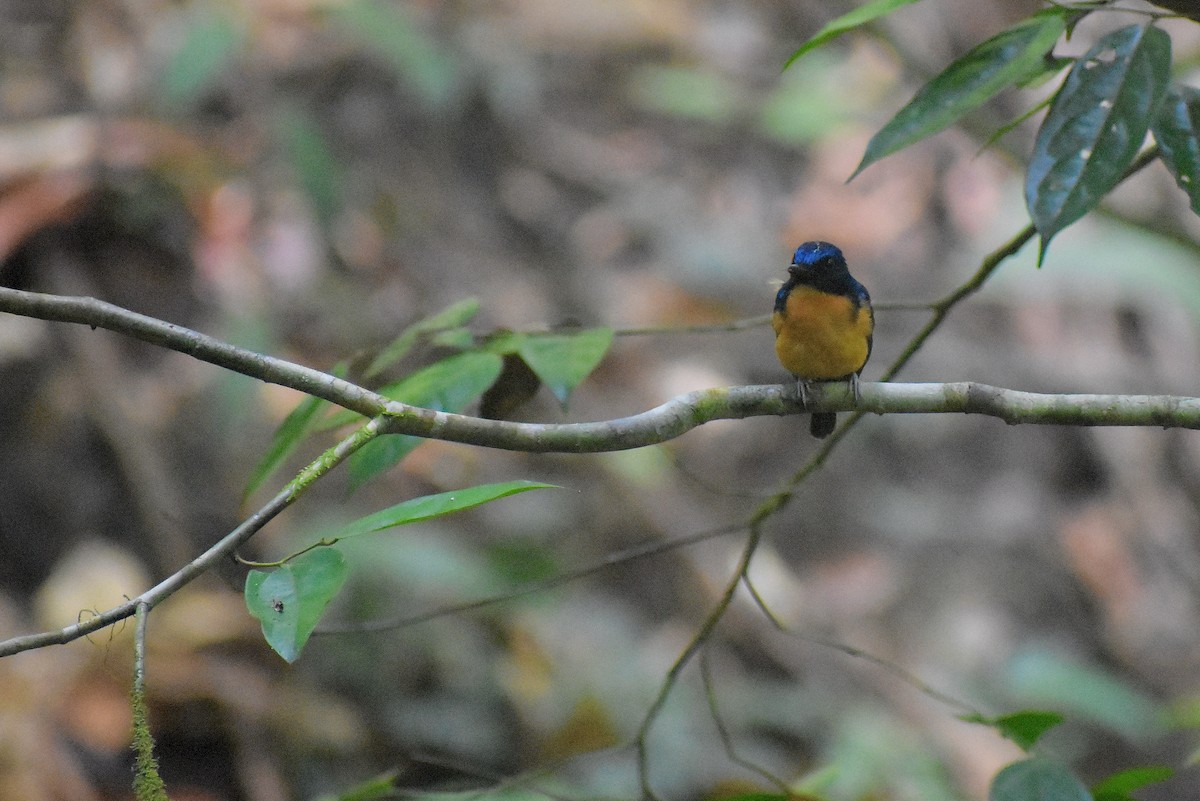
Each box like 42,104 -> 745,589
158,7 -> 244,107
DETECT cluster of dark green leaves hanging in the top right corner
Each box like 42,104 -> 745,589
788,0 -> 1200,264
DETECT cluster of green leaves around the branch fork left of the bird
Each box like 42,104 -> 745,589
245,299 -> 613,662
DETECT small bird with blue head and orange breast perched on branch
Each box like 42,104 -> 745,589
770,242 -> 875,439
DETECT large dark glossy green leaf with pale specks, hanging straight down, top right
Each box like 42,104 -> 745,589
1025,25 -> 1171,264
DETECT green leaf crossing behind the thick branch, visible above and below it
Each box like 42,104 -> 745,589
345,351 -> 503,489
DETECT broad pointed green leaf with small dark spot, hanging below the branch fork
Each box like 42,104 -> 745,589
246,548 -> 347,662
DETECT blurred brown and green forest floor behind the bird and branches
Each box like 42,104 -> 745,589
0,0 -> 1200,801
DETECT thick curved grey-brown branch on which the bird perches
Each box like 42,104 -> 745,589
0,286 -> 1200,453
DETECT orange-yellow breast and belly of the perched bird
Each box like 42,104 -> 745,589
772,287 -> 875,380
